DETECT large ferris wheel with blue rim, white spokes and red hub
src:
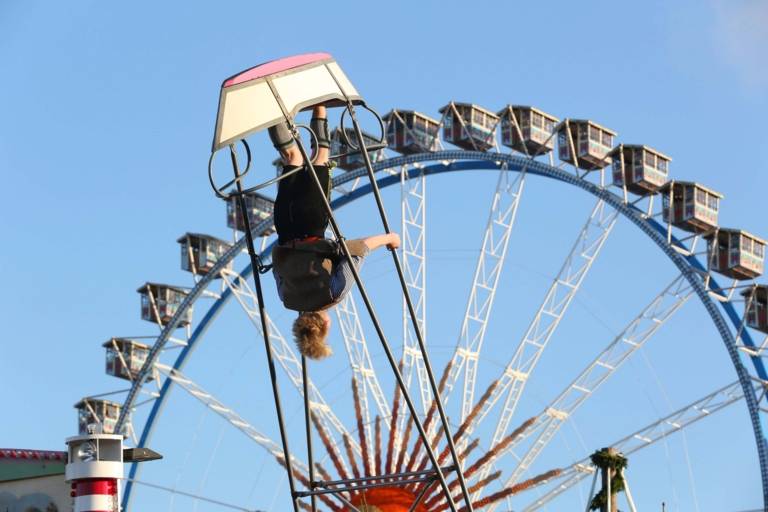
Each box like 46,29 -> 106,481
76,56 -> 768,512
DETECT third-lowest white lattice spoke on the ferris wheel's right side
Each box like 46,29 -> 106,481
470,199 -> 618,445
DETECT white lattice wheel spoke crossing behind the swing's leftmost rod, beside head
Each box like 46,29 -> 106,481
221,270 -> 362,469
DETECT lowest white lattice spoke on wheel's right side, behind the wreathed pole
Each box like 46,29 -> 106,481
523,381 -> 748,512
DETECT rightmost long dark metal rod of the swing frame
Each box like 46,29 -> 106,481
347,102 -> 473,512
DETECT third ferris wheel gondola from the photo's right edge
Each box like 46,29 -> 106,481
659,181 -> 723,233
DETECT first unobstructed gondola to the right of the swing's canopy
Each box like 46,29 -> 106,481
383,110 -> 440,155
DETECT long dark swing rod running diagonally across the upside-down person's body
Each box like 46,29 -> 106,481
289,131 -> 456,512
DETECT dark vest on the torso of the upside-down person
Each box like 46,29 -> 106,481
272,239 -> 365,311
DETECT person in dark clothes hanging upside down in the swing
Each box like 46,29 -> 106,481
269,106 -> 400,359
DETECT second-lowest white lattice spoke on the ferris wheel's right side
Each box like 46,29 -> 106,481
498,275 -> 693,487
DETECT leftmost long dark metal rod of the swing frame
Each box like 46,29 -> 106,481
229,144 -> 299,512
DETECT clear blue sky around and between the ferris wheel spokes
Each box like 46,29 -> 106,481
0,0 -> 768,511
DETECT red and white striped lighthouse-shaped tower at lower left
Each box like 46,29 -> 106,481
66,434 -> 123,512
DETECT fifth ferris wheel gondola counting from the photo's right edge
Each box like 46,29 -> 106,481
557,119 -> 616,171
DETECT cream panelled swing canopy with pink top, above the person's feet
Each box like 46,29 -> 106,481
212,53 -> 363,152
